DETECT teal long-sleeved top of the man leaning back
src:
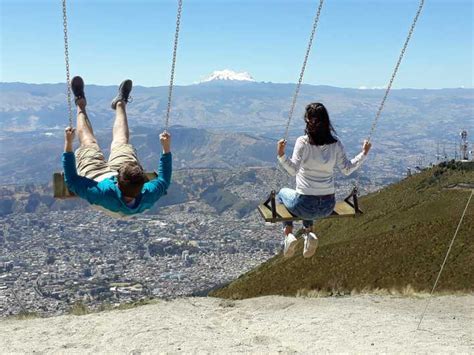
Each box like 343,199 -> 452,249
62,152 -> 172,215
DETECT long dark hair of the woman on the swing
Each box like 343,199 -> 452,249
304,102 -> 337,145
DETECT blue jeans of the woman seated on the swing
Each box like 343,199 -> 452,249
277,187 -> 336,228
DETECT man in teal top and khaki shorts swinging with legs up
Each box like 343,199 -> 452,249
62,76 -> 172,216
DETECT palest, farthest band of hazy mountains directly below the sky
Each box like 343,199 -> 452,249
0,83 -> 474,140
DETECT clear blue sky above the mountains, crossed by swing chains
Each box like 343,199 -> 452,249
0,0 -> 473,88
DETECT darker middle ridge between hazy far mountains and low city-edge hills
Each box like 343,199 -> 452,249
0,126 -> 276,184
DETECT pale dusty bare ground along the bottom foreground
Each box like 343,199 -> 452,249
0,295 -> 474,354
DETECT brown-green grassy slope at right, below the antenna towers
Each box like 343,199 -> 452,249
211,163 -> 474,299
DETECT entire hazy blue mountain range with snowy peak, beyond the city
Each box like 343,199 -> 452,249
0,80 -> 474,184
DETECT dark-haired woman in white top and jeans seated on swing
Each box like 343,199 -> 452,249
277,102 -> 372,258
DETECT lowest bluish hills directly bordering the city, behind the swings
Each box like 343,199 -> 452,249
0,168 -> 298,218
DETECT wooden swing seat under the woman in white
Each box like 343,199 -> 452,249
258,188 -> 362,223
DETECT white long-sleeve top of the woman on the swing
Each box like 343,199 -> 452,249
278,135 -> 366,195
